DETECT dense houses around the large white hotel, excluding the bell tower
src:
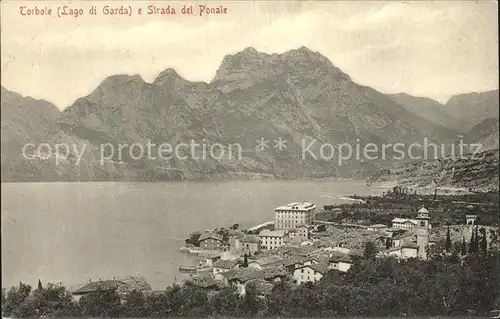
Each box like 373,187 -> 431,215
187,202 -> 354,295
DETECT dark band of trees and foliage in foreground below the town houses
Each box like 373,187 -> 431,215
2,252 -> 500,318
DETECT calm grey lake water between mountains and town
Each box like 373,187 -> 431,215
1,180 -> 373,289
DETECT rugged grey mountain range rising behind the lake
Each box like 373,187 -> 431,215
1,47 -> 498,181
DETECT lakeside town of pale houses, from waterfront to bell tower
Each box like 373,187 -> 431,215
175,192 -> 498,295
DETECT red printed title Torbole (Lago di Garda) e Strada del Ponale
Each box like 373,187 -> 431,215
19,5 -> 228,18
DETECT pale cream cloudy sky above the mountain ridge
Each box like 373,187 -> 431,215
0,1 -> 499,109
